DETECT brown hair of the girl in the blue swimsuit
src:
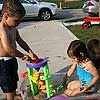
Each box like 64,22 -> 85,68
67,40 -> 89,62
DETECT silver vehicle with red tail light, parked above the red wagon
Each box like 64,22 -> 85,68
83,0 -> 99,16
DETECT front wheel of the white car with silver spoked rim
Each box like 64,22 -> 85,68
40,9 -> 51,21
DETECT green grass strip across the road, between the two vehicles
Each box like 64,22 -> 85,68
42,0 -> 84,9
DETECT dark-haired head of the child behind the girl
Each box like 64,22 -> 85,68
87,39 -> 100,59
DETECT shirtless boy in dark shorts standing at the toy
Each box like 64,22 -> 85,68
0,0 -> 38,100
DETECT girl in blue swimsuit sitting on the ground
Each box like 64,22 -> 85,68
63,40 -> 99,96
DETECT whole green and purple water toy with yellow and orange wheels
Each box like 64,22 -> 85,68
26,59 -> 54,98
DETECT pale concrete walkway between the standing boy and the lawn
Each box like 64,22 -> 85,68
0,21 -> 77,98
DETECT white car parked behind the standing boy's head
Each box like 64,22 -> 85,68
0,0 -> 59,21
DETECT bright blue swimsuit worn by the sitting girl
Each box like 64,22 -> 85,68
77,65 -> 96,90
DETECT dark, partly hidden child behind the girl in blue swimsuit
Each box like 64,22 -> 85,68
87,39 -> 100,69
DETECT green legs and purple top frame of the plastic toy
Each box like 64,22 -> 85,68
26,60 -> 54,98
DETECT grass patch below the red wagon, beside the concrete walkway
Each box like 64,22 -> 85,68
67,24 -> 100,43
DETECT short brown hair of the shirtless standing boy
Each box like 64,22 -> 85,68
2,0 -> 26,17
